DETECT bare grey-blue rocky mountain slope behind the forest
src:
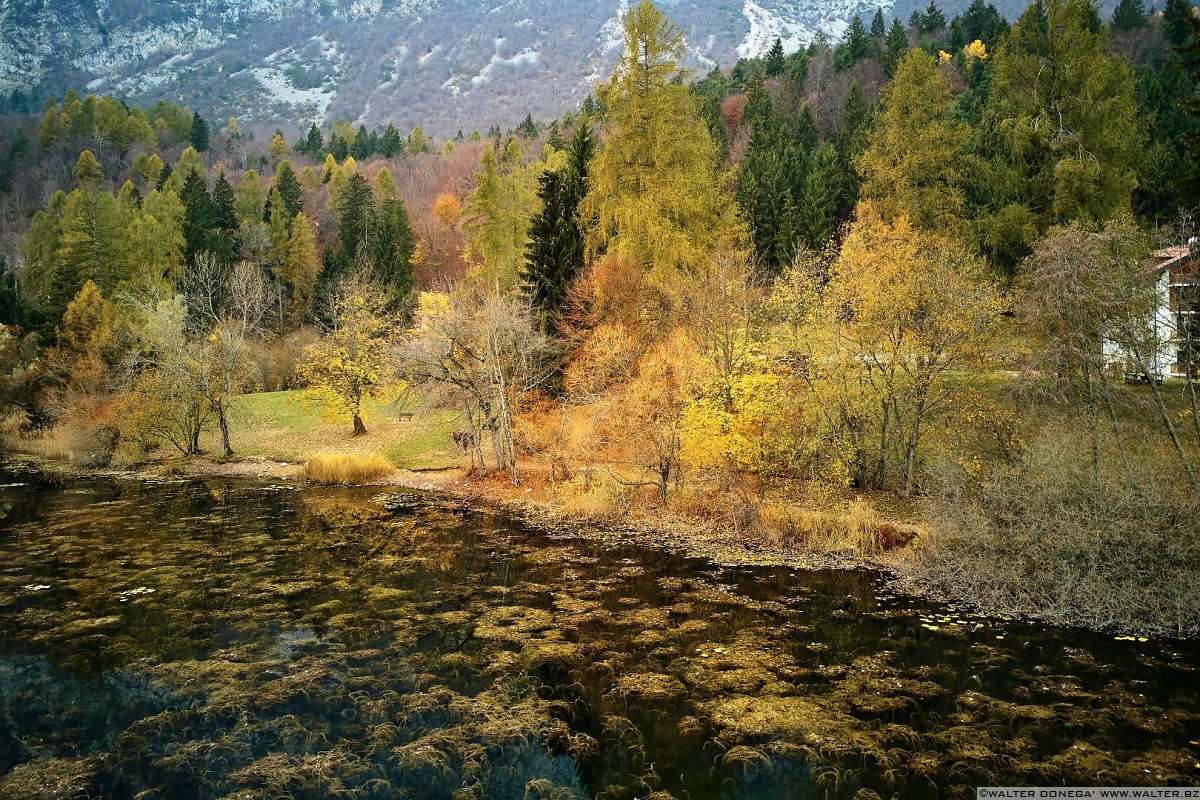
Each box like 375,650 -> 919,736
0,0 -> 945,134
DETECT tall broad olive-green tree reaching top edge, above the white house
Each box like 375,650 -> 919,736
974,0 -> 1144,265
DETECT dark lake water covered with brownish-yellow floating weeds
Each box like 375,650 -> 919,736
0,470 -> 1200,800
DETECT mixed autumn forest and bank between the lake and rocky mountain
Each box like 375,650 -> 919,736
0,0 -> 1200,634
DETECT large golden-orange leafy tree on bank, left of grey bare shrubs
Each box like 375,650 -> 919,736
804,204 -> 1001,493
